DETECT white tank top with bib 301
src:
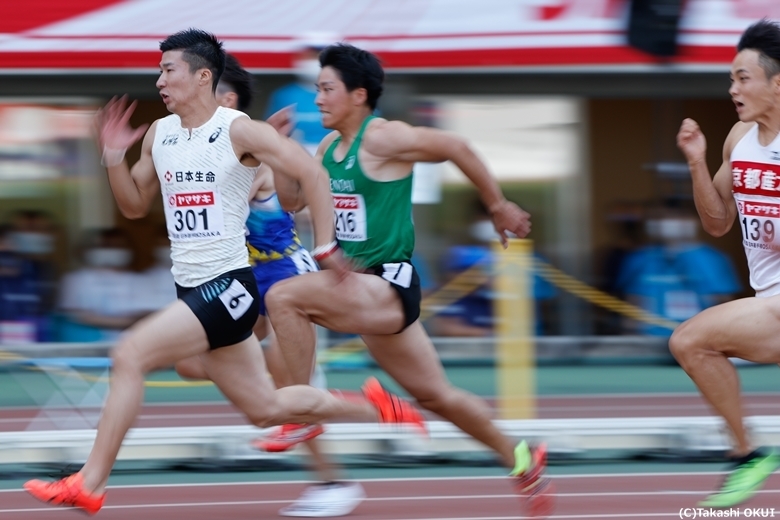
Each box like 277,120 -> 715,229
152,107 -> 257,287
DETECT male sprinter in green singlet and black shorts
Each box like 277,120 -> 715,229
265,44 -> 553,516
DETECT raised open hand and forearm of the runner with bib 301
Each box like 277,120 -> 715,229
96,98 -> 160,219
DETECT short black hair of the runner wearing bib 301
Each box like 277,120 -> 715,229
160,28 -> 225,92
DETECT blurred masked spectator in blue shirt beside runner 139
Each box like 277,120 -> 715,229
615,211 -> 742,336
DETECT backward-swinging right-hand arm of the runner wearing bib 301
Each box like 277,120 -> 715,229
230,117 -> 336,252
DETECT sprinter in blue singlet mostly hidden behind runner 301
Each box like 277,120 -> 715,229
176,54 -> 365,518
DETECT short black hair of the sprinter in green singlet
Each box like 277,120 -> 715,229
320,43 -> 385,110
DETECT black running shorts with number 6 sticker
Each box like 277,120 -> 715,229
176,267 -> 260,350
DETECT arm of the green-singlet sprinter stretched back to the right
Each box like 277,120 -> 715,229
364,121 -> 531,246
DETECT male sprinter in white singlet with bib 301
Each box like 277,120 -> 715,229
24,29 -> 422,514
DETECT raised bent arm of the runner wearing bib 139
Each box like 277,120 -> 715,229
677,119 -> 750,237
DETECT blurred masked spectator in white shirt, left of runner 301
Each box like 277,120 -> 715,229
60,228 -> 148,341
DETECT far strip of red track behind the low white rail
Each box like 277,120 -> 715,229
0,394 -> 780,430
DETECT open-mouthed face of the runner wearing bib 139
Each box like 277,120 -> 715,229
729,49 -> 778,122
